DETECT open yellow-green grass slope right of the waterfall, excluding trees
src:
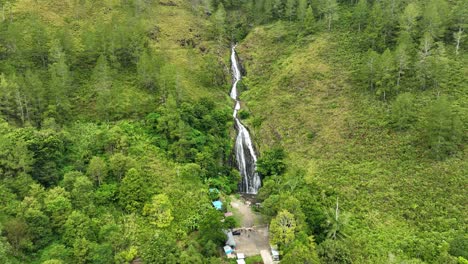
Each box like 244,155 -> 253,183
238,22 -> 468,263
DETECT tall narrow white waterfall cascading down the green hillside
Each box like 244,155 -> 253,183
230,46 -> 261,194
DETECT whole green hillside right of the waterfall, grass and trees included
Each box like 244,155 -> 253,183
234,1 -> 468,263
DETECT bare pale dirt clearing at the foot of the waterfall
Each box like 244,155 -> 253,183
231,197 -> 270,256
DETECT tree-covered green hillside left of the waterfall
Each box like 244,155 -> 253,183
0,0 -> 238,264
